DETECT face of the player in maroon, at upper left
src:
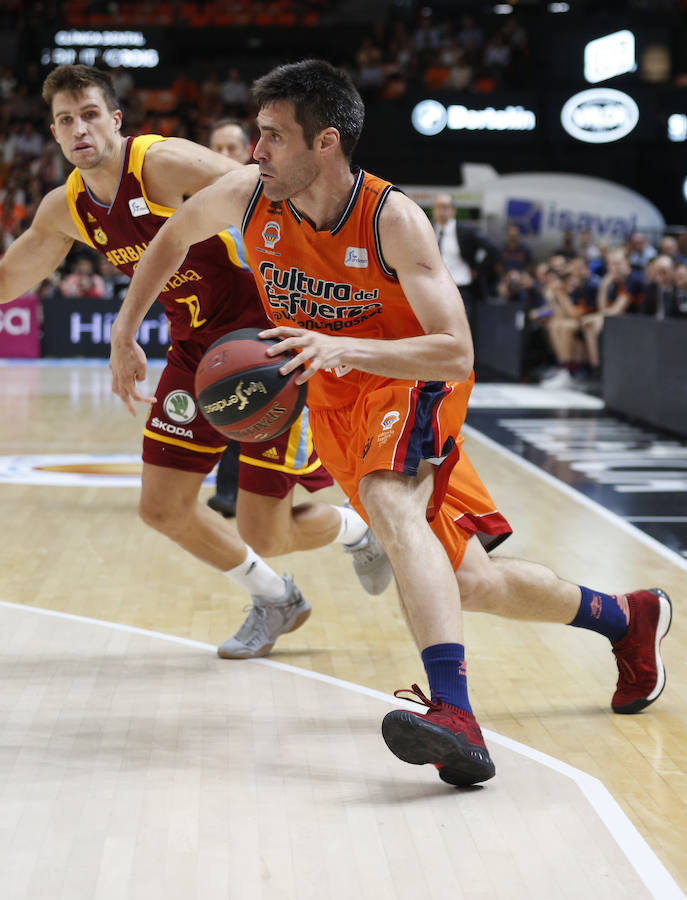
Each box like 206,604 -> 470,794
50,87 -> 122,169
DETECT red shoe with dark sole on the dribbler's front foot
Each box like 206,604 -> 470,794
382,684 -> 496,786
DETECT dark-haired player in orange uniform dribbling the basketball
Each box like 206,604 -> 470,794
117,60 -> 671,785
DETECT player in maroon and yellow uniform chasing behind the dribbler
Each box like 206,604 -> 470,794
0,65 -> 391,658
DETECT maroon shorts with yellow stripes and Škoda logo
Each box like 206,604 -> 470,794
143,361 -> 333,498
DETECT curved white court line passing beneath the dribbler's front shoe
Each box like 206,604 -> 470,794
0,600 -> 687,900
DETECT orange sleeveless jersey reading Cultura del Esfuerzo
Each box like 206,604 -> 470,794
243,170 -> 440,409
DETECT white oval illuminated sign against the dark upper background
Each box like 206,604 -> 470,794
561,88 -> 639,144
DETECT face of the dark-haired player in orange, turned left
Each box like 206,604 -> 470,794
253,100 -> 319,200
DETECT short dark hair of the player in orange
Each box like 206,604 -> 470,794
253,59 -> 365,159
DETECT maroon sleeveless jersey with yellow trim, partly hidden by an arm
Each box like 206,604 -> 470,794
67,134 -> 269,346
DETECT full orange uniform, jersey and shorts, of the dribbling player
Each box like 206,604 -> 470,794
243,170 -> 510,567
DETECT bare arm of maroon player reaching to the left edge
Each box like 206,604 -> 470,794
0,187 -> 79,303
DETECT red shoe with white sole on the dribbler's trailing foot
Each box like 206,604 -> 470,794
611,588 -> 672,713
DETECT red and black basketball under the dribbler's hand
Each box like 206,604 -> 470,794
195,328 -> 307,443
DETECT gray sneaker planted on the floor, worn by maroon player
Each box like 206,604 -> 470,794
217,575 -> 311,659
